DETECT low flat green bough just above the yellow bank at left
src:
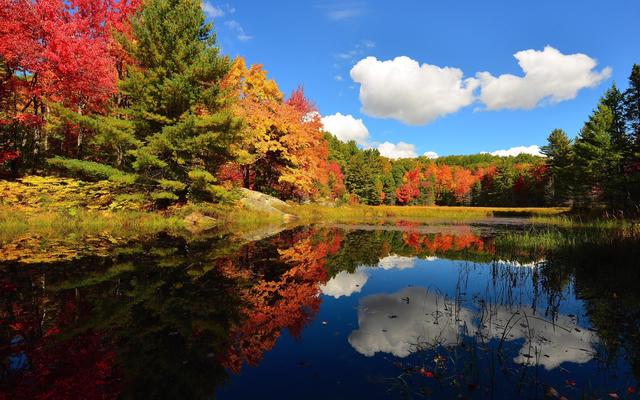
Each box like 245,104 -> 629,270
47,157 -> 137,185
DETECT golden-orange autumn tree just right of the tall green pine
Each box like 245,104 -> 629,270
222,58 -> 328,198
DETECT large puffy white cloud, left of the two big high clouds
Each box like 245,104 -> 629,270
351,56 -> 479,125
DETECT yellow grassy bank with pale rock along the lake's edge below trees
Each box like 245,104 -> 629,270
0,176 -> 637,256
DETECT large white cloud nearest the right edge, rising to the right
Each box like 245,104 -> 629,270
476,46 -> 611,110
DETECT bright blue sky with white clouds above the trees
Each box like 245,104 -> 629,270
204,0 -> 640,156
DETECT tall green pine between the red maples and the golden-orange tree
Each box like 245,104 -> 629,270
120,0 -> 239,179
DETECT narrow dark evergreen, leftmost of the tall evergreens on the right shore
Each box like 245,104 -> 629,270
542,129 -> 573,205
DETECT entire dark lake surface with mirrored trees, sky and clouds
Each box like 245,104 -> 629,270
0,223 -> 640,400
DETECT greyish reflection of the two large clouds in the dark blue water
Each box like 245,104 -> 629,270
349,287 -> 597,369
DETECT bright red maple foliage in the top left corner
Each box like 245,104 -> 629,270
0,0 -> 139,108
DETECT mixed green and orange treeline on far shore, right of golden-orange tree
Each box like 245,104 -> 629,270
326,65 -> 640,214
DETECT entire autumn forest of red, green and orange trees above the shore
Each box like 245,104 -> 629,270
0,0 -> 640,210
